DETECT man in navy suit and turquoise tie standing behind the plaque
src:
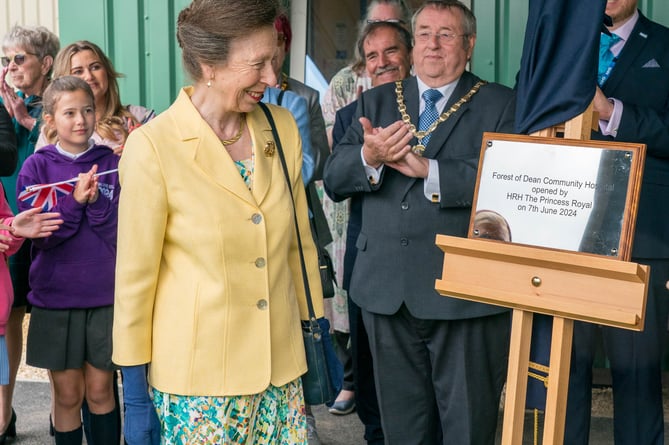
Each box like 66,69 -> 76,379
564,0 -> 669,445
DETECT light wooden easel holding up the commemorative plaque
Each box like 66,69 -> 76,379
435,105 -> 649,445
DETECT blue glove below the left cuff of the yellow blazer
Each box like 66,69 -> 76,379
121,365 -> 160,445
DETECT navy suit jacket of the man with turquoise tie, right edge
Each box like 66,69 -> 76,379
593,15 -> 669,258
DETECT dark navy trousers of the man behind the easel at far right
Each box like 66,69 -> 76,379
564,259 -> 669,445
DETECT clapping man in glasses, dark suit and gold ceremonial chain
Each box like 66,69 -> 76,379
324,0 -> 515,445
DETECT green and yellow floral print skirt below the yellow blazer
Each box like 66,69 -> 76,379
152,378 -> 307,445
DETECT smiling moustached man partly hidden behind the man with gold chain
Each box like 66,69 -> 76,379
332,21 -> 411,445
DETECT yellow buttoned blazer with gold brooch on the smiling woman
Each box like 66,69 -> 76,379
113,88 -> 323,396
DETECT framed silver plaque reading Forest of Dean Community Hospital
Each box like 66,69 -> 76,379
469,133 -> 645,260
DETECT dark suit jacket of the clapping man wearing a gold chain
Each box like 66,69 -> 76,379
324,72 -> 515,319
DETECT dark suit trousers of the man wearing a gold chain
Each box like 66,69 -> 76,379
362,305 -> 510,445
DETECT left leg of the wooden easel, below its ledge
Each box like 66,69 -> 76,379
502,309 -> 534,445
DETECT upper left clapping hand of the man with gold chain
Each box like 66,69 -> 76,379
360,117 -> 413,168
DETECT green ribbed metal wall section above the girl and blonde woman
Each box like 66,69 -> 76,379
58,0 -> 189,111
